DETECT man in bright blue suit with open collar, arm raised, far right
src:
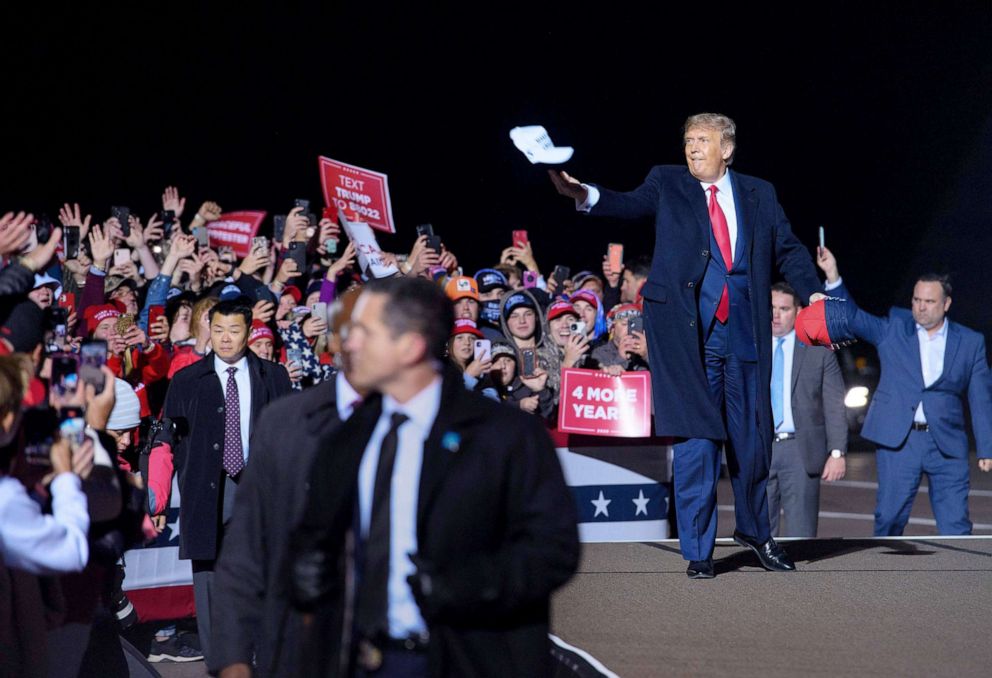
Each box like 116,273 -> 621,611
817,247 -> 992,536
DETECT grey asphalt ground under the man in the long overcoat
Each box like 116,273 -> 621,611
156,452 -> 992,678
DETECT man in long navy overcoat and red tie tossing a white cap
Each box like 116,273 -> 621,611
551,113 -> 823,579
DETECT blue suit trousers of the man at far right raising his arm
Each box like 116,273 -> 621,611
875,431 -> 971,537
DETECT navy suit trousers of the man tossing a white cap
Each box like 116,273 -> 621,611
673,323 -> 771,560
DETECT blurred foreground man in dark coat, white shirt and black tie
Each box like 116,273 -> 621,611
291,278 -> 579,676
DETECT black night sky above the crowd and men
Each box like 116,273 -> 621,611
0,2 -> 992,336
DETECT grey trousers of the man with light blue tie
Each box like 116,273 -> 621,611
768,438 -> 820,537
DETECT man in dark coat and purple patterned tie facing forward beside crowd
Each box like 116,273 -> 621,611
162,299 -> 291,659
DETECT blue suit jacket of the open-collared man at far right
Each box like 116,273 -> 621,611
831,285 -> 992,459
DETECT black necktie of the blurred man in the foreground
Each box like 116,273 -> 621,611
355,412 -> 408,638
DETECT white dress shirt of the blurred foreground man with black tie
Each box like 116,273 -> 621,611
358,376 -> 441,638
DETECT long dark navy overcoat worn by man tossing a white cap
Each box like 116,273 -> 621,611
590,165 -> 820,440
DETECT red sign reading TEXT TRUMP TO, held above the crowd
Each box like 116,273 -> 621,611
318,156 -> 396,233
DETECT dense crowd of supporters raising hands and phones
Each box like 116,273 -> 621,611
0,187 -> 649,675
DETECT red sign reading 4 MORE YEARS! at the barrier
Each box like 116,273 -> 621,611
558,368 -> 651,438
